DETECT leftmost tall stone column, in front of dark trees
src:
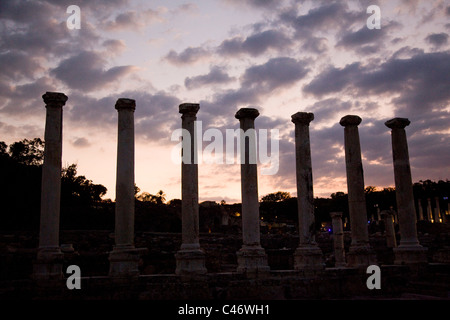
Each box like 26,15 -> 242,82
33,92 -> 68,280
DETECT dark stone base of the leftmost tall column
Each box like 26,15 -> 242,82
32,247 -> 64,280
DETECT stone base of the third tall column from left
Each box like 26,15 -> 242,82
175,246 -> 208,275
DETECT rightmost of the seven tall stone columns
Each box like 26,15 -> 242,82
385,118 -> 426,264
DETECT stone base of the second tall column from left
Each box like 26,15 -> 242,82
108,246 -> 147,278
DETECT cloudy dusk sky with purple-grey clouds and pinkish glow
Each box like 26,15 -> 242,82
0,0 -> 450,202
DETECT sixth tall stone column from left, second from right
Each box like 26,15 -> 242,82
339,115 -> 376,268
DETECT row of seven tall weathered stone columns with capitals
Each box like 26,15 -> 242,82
33,92 -> 425,279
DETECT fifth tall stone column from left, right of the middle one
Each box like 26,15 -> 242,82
292,112 -> 324,270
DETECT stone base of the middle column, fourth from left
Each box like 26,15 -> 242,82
236,245 -> 270,274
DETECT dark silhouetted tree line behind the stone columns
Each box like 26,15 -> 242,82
0,138 -> 450,232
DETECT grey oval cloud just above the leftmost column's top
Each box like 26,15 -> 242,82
50,51 -> 134,91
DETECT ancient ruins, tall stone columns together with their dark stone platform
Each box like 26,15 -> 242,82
1,92 -> 450,299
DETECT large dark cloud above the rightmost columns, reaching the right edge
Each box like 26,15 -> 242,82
303,52 -> 450,112
